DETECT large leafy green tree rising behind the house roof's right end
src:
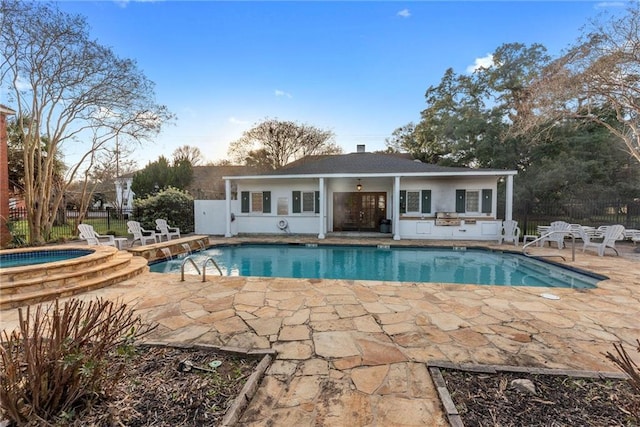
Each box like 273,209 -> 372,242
387,43 -> 549,169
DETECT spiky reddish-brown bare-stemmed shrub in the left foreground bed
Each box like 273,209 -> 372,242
0,299 -> 155,425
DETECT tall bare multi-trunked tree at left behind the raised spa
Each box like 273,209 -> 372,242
0,0 -> 172,243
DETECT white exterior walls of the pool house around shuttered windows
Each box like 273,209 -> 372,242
211,176 -> 501,240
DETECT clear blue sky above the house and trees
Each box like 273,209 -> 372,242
52,0 -> 624,167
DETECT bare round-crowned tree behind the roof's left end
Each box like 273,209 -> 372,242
229,119 -> 342,169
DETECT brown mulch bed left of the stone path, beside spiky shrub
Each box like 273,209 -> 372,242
69,346 -> 270,427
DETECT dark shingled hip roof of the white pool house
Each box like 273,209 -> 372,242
222,153 -> 516,179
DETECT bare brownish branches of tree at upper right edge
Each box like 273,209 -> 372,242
513,3 -> 640,162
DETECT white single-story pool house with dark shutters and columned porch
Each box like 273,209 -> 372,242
218,146 -> 517,240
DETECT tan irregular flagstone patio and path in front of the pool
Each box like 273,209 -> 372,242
1,239 -> 640,427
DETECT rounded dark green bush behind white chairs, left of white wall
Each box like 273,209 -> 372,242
135,187 -> 194,234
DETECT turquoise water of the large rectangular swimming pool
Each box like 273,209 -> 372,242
150,245 -> 606,288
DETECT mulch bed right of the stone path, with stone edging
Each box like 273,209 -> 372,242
430,367 -> 640,427
